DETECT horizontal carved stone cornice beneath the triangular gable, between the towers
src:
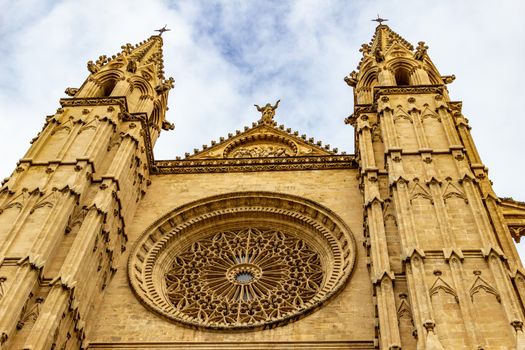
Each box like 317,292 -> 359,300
152,155 -> 358,174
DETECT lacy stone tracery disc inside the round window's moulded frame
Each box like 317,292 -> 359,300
166,228 -> 323,324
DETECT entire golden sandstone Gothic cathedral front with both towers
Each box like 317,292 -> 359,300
0,24 -> 525,350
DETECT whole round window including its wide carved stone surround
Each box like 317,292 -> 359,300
128,192 -> 355,329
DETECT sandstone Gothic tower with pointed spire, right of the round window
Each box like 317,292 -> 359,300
345,23 -> 525,349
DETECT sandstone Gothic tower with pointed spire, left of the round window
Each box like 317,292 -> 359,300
0,32 -> 173,349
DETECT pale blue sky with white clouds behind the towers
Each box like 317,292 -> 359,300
0,0 -> 525,252
